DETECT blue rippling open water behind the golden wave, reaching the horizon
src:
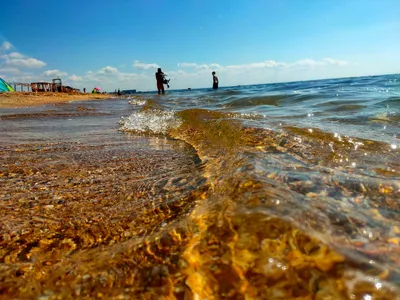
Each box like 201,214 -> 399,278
130,75 -> 400,142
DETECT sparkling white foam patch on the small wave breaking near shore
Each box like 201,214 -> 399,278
120,110 -> 182,134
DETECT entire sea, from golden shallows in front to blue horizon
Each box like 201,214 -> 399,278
0,74 -> 400,300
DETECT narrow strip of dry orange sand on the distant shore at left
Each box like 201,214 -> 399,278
0,92 -> 112,108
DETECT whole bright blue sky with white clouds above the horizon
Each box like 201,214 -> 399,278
0,0 -> 400,91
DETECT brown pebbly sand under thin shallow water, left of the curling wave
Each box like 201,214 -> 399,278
0,136 -> 208,298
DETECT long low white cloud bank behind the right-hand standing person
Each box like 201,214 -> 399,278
166,58 -> 356,89
